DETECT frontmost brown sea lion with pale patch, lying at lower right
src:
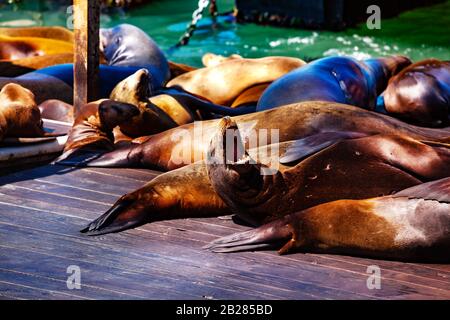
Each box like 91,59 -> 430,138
205,178 -> 450,263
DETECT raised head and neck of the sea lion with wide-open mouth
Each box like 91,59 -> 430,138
206,117 -> 283,225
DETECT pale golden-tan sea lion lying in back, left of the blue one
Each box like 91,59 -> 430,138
167,57 -> 305,106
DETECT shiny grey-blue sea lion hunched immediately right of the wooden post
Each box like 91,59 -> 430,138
100,24 -> 170,88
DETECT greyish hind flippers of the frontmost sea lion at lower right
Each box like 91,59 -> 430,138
203,216 -> 292,253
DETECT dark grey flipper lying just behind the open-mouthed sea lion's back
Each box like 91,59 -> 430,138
280,131 -> 367,164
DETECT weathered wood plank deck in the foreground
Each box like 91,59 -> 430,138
0,165 -> 450,299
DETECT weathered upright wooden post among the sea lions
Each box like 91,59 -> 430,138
73,0 -> 100,114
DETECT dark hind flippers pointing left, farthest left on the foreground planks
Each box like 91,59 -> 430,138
80,194 -> 146,236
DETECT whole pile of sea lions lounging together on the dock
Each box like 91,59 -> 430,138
0,25 -> 450,261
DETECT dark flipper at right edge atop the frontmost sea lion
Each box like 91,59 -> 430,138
391,178 -> 450,203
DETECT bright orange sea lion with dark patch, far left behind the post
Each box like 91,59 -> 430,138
0,35 -> 73,60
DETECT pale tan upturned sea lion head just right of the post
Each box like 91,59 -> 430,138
109,69 -> 153,105
